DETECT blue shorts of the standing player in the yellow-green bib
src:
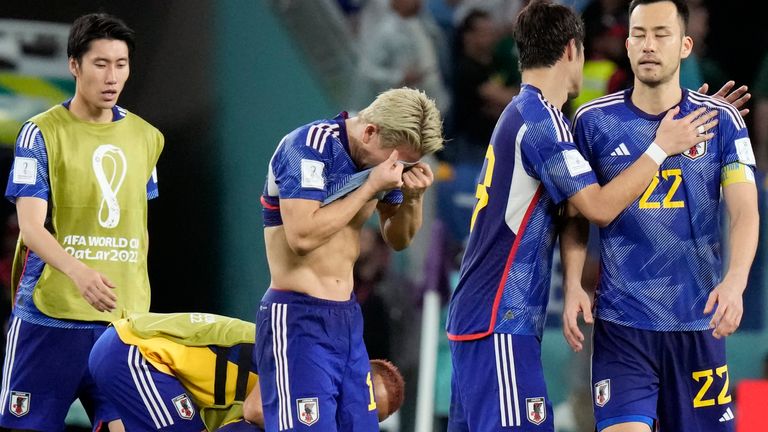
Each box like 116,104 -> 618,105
0,315 -> 118,431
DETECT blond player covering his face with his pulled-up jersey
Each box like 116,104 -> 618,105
254,88 -> 443,431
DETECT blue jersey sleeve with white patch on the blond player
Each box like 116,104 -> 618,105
272,129 -> 333,201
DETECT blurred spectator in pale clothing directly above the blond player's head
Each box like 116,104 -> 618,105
352,0 -> 450,112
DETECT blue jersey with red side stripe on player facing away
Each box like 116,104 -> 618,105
447,85 -> 597,340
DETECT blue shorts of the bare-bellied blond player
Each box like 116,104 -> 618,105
253,289 -> 379,432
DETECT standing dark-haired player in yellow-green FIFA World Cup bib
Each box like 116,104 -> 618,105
0,14 -> 164,431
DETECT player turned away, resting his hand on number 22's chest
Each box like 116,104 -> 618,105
447,1 -> 715,432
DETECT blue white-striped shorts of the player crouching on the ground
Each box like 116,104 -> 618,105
89,327 -> 205,432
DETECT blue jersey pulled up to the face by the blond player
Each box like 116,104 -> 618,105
261,112 -> 403,227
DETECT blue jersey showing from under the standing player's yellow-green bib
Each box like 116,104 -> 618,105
5,100 -> 158,329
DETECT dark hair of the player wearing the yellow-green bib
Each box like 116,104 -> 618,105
67,13 -> 135,62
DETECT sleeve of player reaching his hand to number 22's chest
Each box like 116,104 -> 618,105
521,117 -> 597,203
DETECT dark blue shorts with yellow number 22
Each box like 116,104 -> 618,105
592,320 -> 734,432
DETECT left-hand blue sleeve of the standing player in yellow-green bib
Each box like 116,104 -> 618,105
5,122 -> 51,203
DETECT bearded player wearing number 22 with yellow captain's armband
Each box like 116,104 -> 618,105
564,0 -> 758,432
